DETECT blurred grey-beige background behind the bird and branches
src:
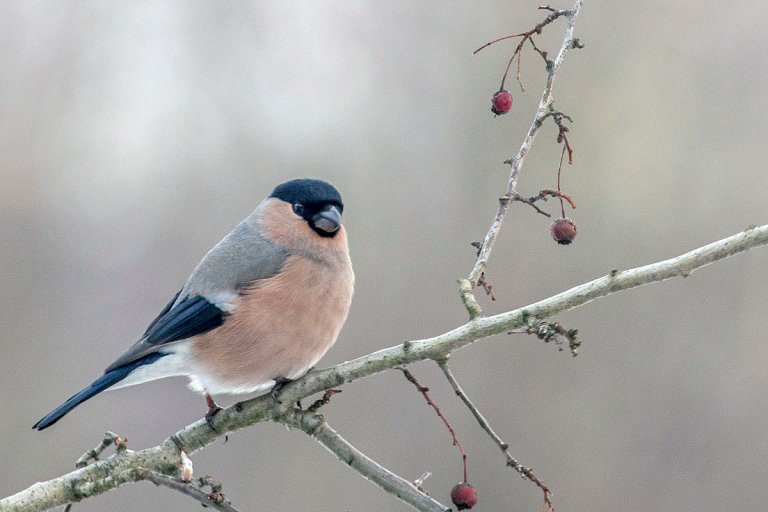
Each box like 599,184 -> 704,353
0,0 -> 768,512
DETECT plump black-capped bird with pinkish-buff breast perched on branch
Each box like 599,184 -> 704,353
33,178 -> 355,430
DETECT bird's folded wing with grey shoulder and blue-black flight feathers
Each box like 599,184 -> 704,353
105,214 -> 288,372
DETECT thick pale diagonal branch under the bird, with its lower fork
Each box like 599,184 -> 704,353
0,225 -> 768,512
